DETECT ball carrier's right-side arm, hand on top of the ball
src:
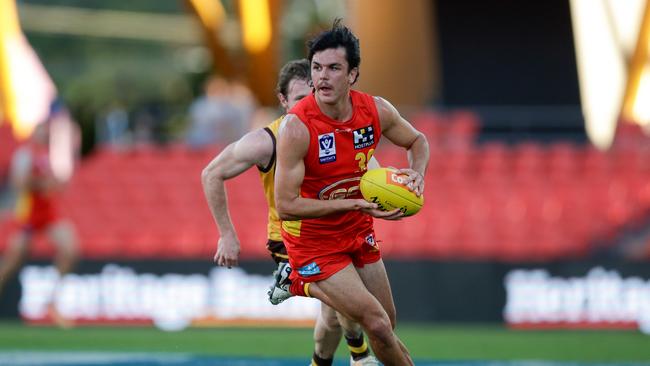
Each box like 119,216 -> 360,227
375,97 -> 429,196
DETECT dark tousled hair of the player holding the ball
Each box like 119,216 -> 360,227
307,18 -> 361,82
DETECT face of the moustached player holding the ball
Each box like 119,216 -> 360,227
311,47 -> 357,104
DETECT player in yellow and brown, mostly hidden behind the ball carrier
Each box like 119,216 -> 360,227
201,59 -> 377,365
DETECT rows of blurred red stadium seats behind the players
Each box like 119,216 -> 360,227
0,112 -> 650,261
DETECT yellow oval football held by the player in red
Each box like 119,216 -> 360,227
359,168 -> 424,216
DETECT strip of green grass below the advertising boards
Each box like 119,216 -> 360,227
0,322 -> 650,361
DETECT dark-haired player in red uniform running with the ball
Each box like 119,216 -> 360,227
275,20 -> 429,365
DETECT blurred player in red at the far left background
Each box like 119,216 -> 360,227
0,122 -> 79,326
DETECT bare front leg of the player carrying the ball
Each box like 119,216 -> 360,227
309,264 -> 412,366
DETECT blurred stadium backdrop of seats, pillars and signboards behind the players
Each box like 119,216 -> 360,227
0,0 -> 650,362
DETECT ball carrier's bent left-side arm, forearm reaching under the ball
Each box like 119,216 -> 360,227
275,114 -> 377,220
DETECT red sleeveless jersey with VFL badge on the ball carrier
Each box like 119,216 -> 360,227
282,90 -> 381,238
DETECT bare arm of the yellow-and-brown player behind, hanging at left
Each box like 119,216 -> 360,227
201,129 -> 273,267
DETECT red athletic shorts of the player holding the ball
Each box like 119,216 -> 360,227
282,228 -> 381,284
